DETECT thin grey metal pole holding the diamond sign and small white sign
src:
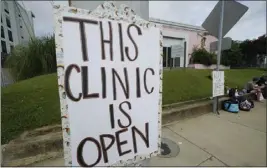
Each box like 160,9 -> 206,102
213,0 -> 224,114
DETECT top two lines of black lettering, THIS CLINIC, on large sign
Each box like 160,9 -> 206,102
63,17 -> 155,102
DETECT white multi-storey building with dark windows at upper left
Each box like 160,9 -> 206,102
1,0 -> 35,55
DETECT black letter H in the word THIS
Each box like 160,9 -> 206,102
100,22 -> 113,61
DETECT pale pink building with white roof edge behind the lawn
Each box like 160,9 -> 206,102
149,18 -> 217,67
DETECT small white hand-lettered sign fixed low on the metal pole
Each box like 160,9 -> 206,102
212,71 -> 224,97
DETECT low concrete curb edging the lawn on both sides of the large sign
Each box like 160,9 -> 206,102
1,94 -> 254,166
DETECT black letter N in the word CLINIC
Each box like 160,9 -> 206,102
112,68 -> 130,100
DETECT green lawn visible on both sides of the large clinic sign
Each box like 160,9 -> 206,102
1,69 -> 264,144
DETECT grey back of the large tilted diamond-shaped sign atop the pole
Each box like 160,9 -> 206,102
202,0 -> 248,38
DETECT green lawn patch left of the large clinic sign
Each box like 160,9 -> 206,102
1,74 -> 61,144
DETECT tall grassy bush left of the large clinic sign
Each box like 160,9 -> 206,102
5,36 -> 56,80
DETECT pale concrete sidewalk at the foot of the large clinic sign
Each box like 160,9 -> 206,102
32,101 -> 266,166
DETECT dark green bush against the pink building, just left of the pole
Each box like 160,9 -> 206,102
192,48 -> 216,66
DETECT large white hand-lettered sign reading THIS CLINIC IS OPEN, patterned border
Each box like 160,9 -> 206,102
54,2 -> 162,167
